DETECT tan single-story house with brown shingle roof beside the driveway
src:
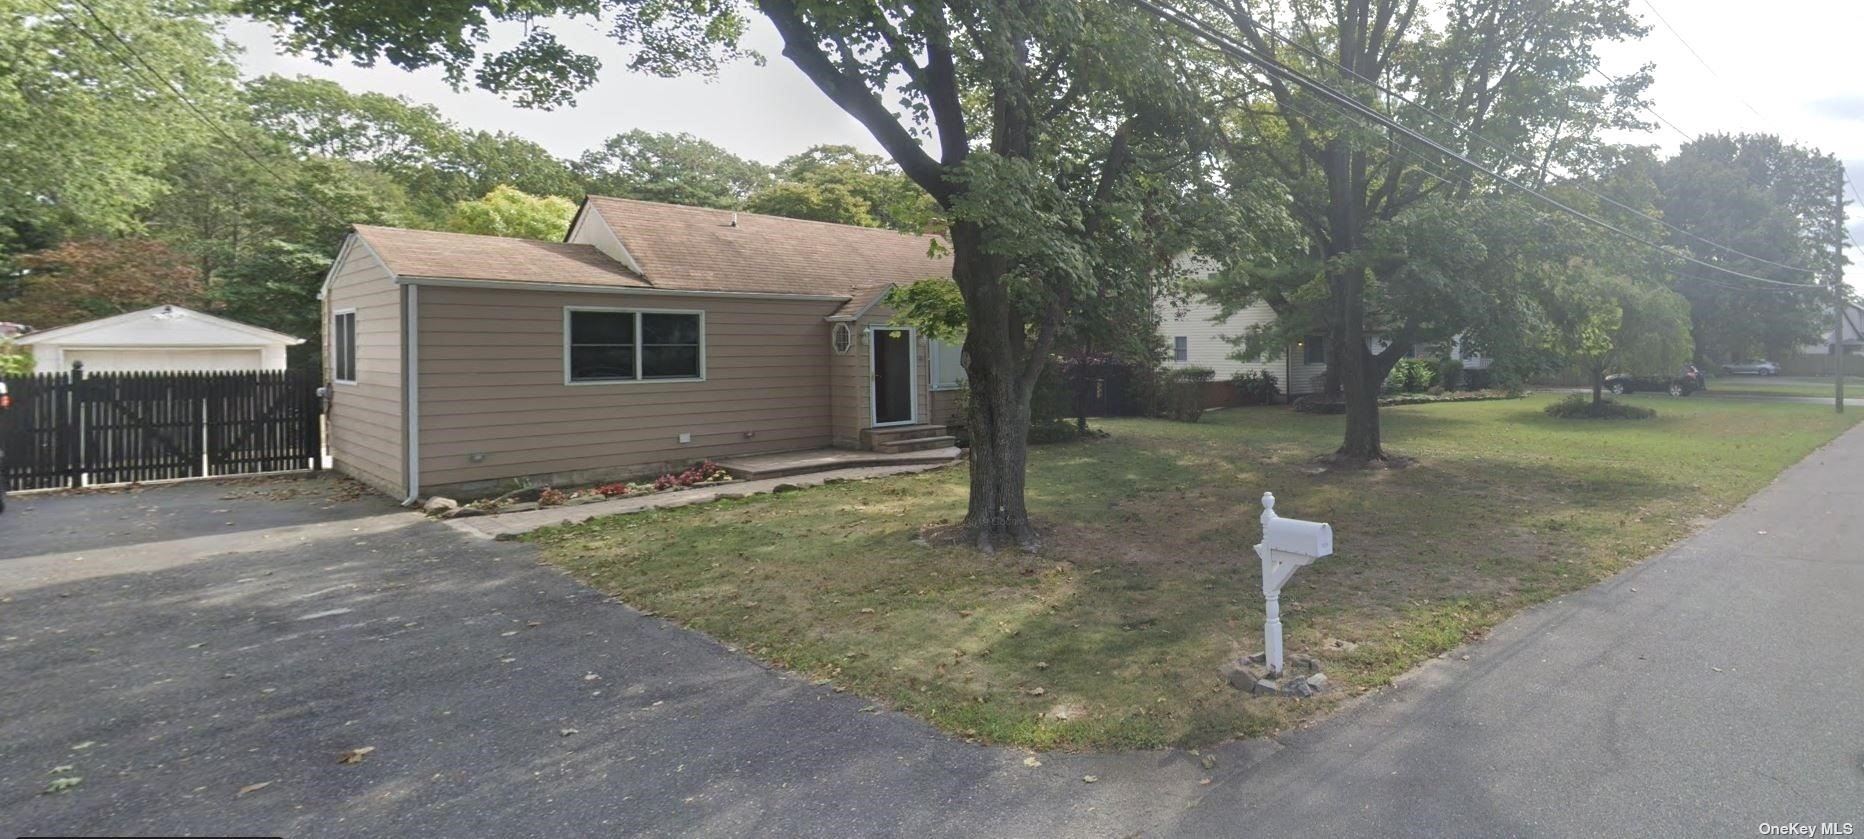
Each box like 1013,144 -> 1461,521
321,196 -> 962,498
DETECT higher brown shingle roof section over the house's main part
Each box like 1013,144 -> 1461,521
580,196 -> 951,296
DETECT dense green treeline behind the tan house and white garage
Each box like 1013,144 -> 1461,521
0,0 -> 934,364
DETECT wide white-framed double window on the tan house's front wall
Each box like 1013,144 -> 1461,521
563,306 -> 705,384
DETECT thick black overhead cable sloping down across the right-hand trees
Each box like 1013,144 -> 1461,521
1128,0 -> 1817,289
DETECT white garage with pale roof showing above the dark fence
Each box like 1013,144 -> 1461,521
15,306 -> 304,373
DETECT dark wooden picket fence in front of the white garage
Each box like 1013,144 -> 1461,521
0,369 -> 322,490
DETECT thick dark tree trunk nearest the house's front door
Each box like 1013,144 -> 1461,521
951,222 -> 1044,550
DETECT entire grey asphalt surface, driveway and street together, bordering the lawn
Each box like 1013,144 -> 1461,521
0,429 -> 1864,837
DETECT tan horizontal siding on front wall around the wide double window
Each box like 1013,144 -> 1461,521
418,285 -> 837,490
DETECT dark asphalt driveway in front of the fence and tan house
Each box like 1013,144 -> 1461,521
0,477 -> 1206,837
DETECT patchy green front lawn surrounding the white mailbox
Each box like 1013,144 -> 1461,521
531,397 -> 1858,750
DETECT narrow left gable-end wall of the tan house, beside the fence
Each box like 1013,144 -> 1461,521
322,244 -> 408,498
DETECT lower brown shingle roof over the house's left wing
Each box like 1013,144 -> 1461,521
354,224 -> 647,287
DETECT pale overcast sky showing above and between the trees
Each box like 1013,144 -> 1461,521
231,0 -> 1864,287
